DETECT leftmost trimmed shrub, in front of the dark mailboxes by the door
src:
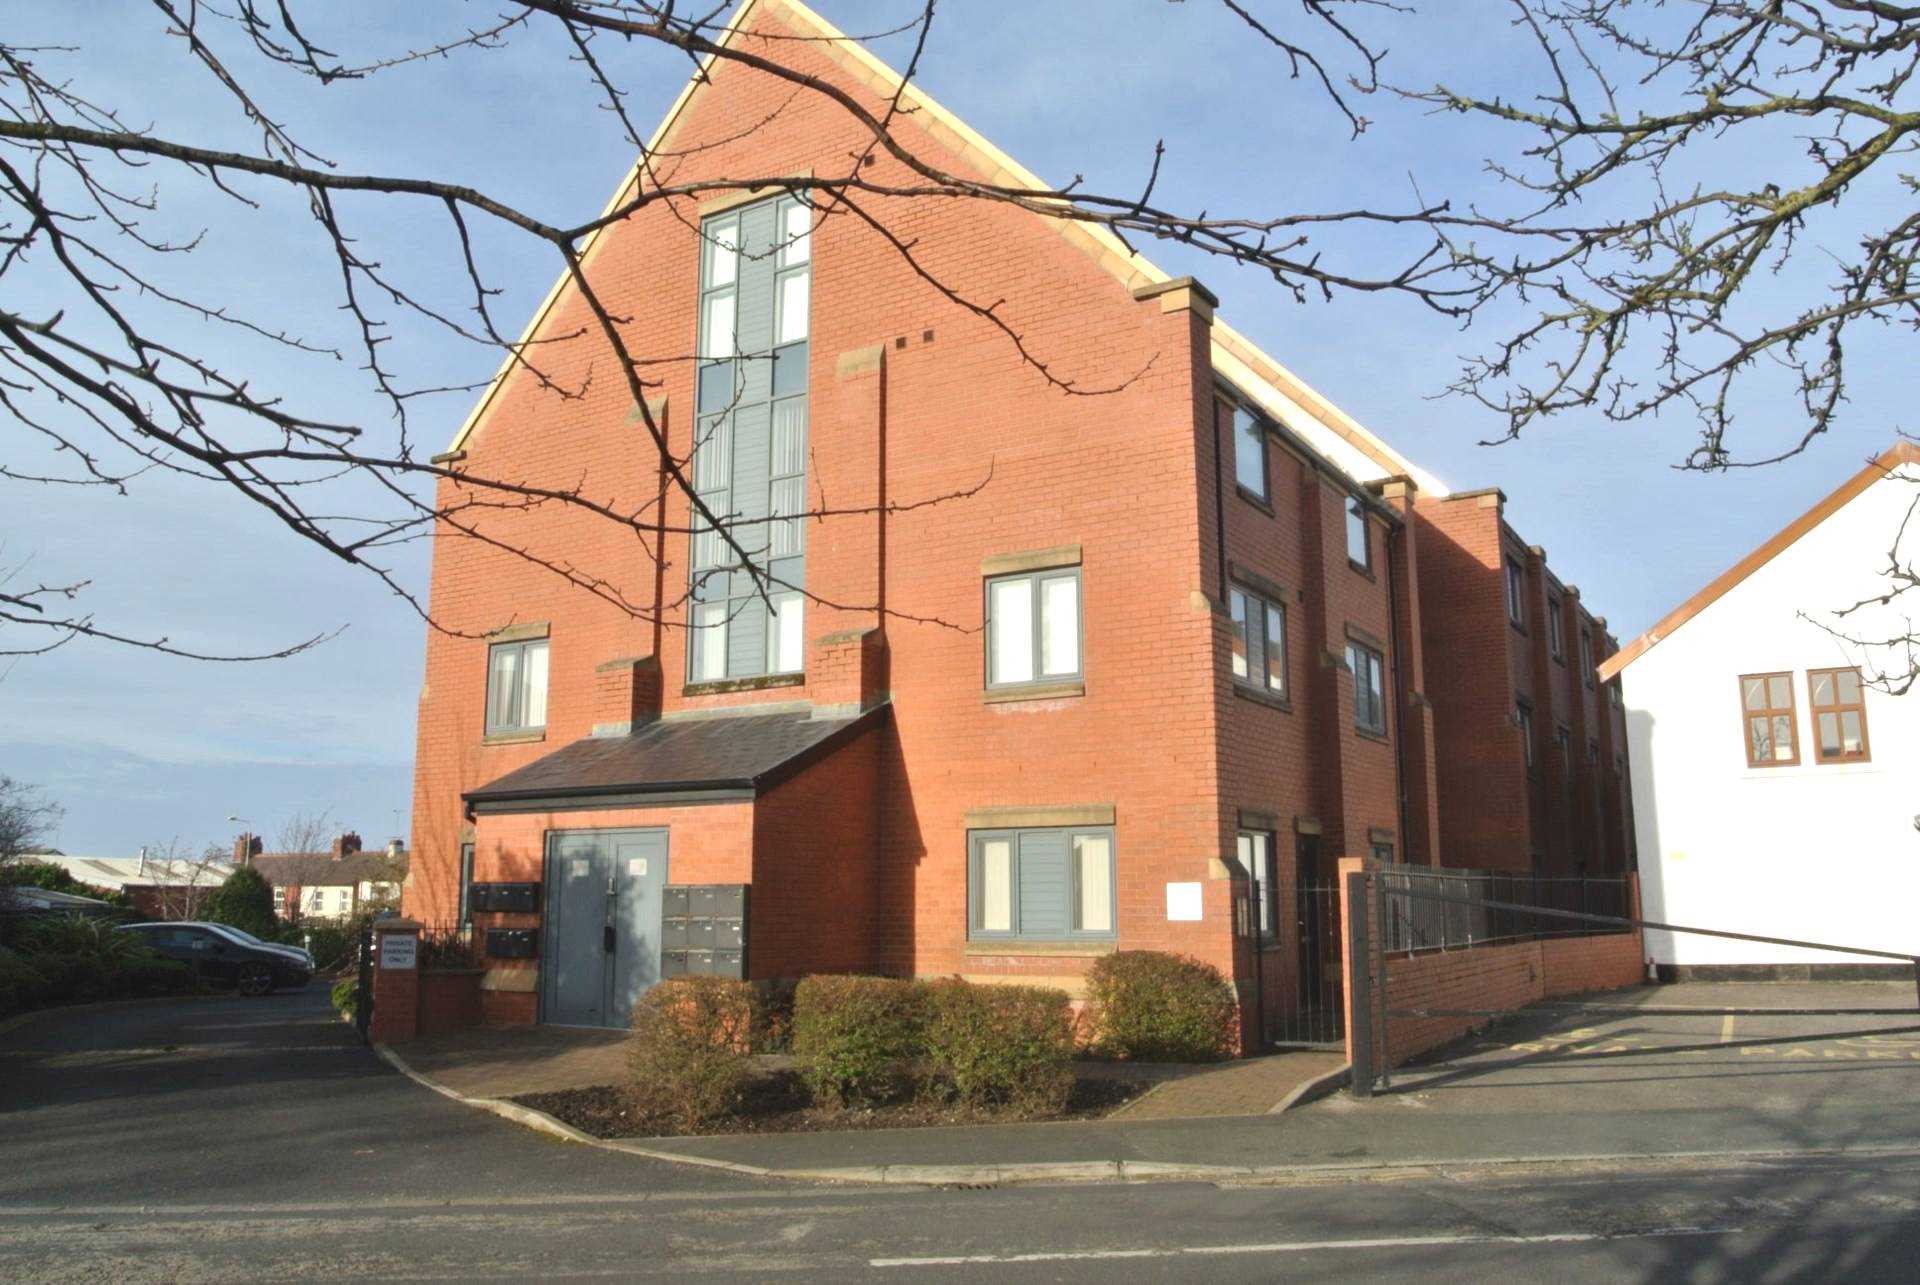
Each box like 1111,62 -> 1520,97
628,978 -> 755,1131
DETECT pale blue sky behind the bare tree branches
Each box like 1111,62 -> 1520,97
0,0 -> 1910,853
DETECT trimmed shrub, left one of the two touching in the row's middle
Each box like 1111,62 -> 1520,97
793,976 -> 925,1106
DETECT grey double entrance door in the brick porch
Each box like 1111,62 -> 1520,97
540,830 -> 666,1026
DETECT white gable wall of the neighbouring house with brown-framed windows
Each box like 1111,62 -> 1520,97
1622,465 -> 1920,964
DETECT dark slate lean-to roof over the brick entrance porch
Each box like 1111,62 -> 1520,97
465,705 -> 889,812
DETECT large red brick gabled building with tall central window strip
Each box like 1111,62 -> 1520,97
407,0 -> 1617,1030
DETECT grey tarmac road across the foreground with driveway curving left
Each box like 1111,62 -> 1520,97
0,987 -> 1920,1281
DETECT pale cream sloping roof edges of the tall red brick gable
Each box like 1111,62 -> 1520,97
447,0 -> 1448,496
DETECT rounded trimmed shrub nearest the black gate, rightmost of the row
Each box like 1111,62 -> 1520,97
1087,951 -> 1238,1062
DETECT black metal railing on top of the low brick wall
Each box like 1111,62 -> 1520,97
1379,866 -> 1632,953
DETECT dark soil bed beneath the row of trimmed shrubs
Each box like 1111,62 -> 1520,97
511,1070 -> 1148,1137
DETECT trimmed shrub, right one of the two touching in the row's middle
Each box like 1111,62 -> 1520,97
925,978 -> 1073,1116
